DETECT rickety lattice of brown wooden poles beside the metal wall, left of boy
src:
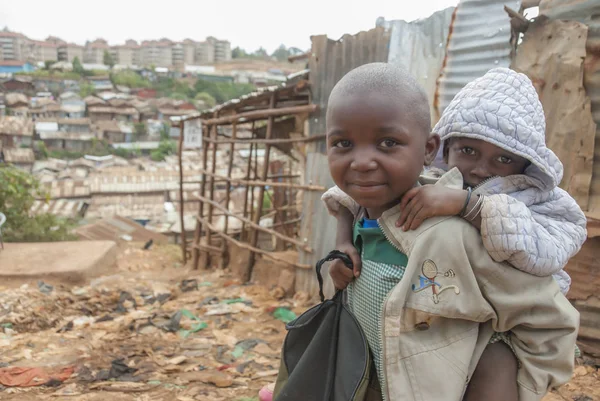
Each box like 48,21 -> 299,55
179,73 -> 326,281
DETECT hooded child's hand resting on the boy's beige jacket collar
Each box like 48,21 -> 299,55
396,185 -> 467,231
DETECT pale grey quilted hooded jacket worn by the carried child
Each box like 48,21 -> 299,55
322,68 -> 587,293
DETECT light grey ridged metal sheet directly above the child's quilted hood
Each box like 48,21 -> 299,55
435,0 -> 521,115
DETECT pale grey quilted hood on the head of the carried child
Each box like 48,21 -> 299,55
433,68 -> 563,191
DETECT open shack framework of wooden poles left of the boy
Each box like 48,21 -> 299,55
179,74 -> 324,280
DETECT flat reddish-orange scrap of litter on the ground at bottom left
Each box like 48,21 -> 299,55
0,366 -> 75,387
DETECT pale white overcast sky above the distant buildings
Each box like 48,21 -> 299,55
0,0 -> 458,52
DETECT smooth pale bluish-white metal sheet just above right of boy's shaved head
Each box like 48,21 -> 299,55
384,7 -> 454,123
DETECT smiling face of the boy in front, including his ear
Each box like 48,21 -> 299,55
327,94 -> 439,219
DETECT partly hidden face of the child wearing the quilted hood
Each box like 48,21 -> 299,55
446,138 -> 529,187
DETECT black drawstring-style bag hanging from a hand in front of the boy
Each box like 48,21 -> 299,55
273,251 -> 371,401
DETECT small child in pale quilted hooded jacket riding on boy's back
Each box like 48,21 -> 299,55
323,69 -> 586,400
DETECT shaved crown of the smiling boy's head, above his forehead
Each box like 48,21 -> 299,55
327,63 -> 431,134
